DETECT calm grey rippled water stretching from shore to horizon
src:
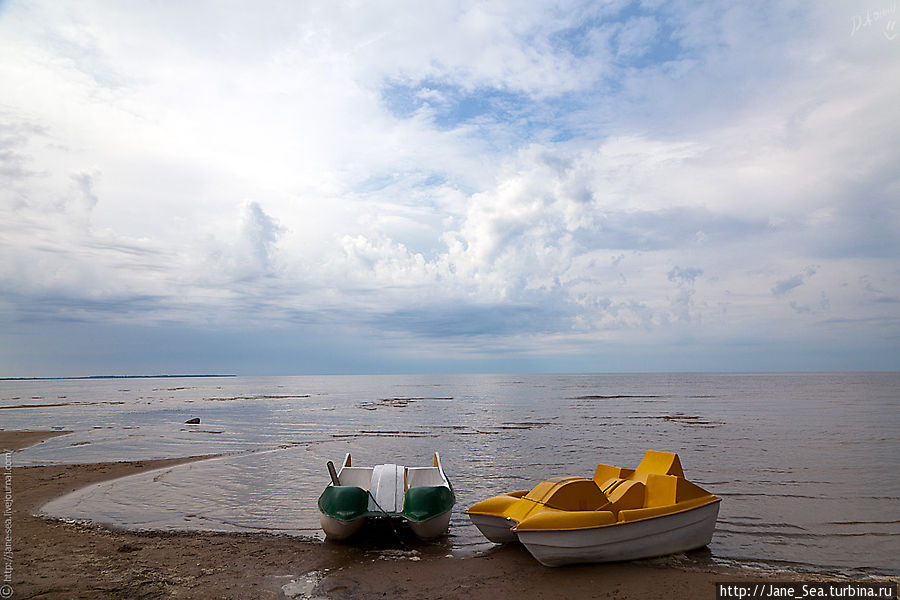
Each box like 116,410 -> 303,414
0,373 -> 900,576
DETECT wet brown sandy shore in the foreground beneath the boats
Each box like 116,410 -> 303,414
0,431 -> 864,600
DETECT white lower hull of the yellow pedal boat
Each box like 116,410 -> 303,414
516,501 -> 719,567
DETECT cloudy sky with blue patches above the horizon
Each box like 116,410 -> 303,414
0,0 -> 900,377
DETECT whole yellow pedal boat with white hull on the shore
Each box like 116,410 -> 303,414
466,450 -> 721,567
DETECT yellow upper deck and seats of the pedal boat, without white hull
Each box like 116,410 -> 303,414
466,450 -> 719,532
